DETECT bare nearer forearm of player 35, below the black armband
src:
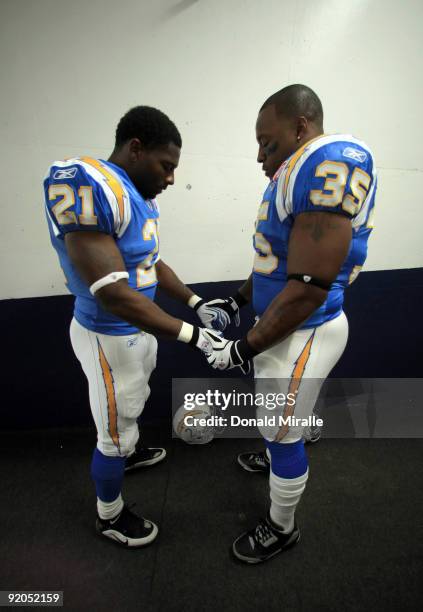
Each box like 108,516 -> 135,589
247,281 -> 327,353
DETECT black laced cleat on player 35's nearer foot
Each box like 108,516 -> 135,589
232,515 -> 300,563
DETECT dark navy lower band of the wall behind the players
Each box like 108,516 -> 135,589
0,268 -> 423,429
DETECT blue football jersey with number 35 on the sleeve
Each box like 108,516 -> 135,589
253,134 -> 377,328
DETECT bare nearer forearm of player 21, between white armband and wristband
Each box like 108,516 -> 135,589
96,282 -> 182,339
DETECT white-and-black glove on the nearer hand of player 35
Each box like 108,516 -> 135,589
203,332 -> 257,374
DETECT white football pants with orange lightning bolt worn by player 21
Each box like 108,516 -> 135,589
70,319 -> 157,457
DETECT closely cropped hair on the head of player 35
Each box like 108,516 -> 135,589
260,84 -> 323,127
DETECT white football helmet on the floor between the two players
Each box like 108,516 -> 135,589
173,405 -> 216,444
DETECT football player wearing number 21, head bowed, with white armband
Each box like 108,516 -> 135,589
44,106 -> 217,547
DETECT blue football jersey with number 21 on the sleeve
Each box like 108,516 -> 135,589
44,157 -> 159,335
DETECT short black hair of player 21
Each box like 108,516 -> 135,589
115,106 -> 182,149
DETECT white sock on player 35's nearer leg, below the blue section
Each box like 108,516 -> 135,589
269,470 -> 308,533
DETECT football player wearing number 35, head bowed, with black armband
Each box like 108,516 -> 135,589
198,85 -> 377,563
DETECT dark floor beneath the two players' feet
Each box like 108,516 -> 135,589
0,430 -> 423,612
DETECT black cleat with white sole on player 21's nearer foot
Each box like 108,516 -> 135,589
96,505 -> 159,548
